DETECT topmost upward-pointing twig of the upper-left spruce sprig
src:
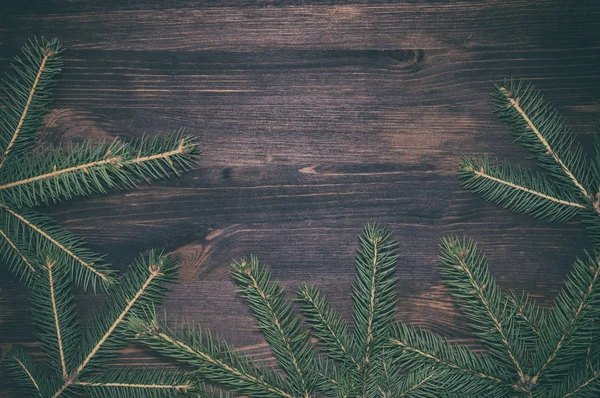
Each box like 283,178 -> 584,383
0,38 -> 62,168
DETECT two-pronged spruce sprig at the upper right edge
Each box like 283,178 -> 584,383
460,80 -> 600,239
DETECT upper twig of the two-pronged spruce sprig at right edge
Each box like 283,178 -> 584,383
494,80 -> 592,200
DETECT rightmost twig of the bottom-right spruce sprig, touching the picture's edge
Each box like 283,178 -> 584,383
532,256 -> 600,383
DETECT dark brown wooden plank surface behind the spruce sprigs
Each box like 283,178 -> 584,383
0,0 -> 600,397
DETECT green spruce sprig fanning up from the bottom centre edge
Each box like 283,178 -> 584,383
129,225 -> 435,397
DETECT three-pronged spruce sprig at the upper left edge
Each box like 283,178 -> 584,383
0,38 -> 198,290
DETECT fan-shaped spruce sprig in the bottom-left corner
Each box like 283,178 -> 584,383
4,251 -> 197,398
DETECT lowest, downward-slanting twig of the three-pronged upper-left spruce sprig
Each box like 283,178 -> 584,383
0,202 -> 114,291
